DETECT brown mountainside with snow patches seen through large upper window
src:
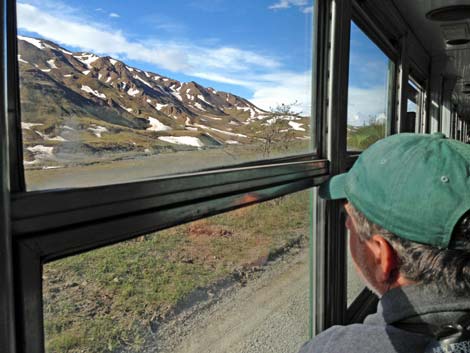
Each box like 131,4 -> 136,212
18,36 -> 309,167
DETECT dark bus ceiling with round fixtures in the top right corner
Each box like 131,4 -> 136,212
393,0 -> 470,121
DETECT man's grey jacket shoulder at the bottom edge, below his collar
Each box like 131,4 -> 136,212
299,324 -> 428,353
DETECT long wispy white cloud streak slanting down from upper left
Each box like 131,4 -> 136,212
18,3 -> 280,73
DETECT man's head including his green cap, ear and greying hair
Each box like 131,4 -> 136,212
320,134 -> 470,295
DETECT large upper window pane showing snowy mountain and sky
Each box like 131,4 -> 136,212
17,0 -> 313,190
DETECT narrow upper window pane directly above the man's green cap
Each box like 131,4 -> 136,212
347,22 -> 394,151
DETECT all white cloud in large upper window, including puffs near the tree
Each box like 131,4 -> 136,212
17,0 -> 310,114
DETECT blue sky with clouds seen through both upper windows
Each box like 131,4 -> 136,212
18,0 -> 390,121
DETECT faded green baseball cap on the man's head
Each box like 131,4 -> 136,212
320,133 -> 470,248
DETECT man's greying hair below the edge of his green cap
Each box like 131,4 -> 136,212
348,204 -> 470,295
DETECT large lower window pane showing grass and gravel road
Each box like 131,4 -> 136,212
43,191 -> 310,353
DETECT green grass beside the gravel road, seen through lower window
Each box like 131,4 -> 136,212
43,191 -> 309,352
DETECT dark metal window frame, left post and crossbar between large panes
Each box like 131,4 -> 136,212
0,0 -> 329,353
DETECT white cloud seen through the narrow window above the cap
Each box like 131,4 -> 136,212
348,86 -> 387,125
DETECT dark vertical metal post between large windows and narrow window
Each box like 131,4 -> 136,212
314,0 -> 352,333
